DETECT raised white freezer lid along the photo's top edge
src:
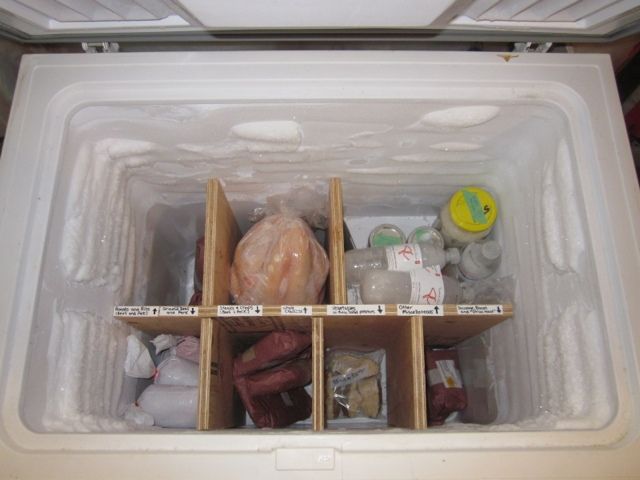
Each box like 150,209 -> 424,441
0,0 -> 640,41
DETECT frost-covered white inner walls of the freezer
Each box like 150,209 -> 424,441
22,100 -> 616,432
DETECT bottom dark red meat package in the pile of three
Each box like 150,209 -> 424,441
235,377 -> 311,428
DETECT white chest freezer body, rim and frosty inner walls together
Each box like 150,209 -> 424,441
0,2 -> 640,479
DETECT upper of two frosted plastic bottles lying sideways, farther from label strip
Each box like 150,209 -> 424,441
345,243 -> 460,284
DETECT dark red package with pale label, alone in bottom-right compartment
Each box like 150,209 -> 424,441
426,349 -> 467,425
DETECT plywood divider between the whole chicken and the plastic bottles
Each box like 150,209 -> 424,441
328,178 -> 347,304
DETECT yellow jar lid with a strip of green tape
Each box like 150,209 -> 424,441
449,187 -> 498,232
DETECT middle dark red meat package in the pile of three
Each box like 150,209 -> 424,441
239,358 -> 311,396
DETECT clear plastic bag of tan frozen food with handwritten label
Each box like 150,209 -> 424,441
325,349 -> 384,420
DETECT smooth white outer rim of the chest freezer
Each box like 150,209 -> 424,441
0,52 -> 640,479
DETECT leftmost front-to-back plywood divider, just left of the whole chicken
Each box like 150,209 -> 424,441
198,179 -> 240,430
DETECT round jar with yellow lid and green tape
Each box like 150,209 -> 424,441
440,187 -> 498,248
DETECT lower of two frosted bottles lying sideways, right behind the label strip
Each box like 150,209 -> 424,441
360,266 -> 462,305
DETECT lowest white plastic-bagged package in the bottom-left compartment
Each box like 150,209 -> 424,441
138,384 -> 198,428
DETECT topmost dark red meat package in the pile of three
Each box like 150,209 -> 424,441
233,331 -> 311,378
